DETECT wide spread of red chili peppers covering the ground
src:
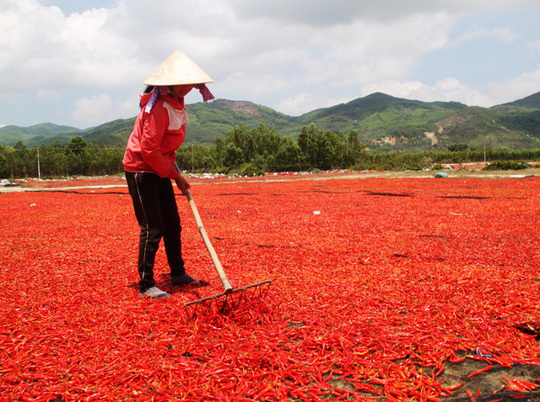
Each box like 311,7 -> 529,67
0,177 -> 540,401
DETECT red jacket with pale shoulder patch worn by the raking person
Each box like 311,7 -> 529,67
123,93 -> 187,179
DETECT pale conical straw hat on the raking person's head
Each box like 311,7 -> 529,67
144,50 -> 214,86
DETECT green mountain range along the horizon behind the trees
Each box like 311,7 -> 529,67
0,92 -> 540,152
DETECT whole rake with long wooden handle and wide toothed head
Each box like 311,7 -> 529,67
184,189 -> 272,318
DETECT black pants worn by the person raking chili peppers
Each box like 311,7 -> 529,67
126,172 -> 185,291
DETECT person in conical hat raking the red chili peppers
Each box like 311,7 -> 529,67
123,50 -> 214,298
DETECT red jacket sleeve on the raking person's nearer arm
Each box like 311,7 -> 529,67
141,105 -> 179,179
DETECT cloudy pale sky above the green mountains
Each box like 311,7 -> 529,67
0,0 -> 540,129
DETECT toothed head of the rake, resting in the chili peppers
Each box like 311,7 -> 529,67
184,279 -> 272,320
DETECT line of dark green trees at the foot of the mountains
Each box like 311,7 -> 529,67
0,124 -> 540,179
